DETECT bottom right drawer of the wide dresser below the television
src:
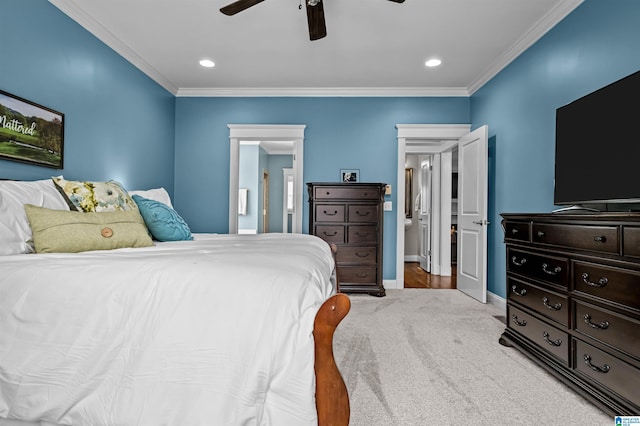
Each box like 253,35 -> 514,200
574,339 -> 640,404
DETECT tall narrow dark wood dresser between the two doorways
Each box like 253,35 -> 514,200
307,182 -> 387,296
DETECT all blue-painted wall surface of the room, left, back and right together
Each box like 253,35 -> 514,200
5,0 -> 640,296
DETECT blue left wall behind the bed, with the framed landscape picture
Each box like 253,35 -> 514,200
0,0 -> 175,193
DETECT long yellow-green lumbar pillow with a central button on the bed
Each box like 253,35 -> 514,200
24,204 -> 153,253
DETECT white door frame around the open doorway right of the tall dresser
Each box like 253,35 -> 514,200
396,124 -> 471,289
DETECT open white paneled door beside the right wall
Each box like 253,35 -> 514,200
457,126 -> 489,303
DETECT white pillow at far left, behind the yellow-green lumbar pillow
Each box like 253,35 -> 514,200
0,179 -> 69,255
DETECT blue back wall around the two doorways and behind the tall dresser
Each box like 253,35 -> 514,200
175,97 -> 471,279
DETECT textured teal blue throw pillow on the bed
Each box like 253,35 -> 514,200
133,195 -> 193,241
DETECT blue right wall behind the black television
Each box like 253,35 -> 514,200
471,0 -> 640,297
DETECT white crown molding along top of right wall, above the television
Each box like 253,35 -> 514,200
467,0 -> 584,96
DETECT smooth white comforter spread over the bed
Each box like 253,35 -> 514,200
0,234 -> 334,426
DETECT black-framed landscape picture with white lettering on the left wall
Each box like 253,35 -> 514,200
0,90 -> 64,169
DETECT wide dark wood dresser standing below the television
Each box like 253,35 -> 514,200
500,213 -> 640,416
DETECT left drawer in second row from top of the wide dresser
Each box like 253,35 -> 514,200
507,248 -> 569,287
